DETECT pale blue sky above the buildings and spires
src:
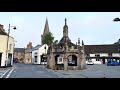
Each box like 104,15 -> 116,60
0,12 -> 120,48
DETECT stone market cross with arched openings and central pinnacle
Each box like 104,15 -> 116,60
47,19 -> 86,70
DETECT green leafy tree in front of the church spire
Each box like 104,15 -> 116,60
42,32 -> 54,46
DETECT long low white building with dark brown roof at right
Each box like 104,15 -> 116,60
84,41 -> 120,64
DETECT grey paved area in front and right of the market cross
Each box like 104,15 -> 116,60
50,65 -> 120,78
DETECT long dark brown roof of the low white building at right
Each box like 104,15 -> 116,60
84,44 -> 120,54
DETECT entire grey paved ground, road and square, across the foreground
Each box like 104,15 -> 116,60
0,63 -> 120,78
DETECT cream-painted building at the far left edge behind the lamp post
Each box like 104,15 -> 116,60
0,24 -> 14,67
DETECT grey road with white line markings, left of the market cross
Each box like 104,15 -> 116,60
2,63 -> 61,78
